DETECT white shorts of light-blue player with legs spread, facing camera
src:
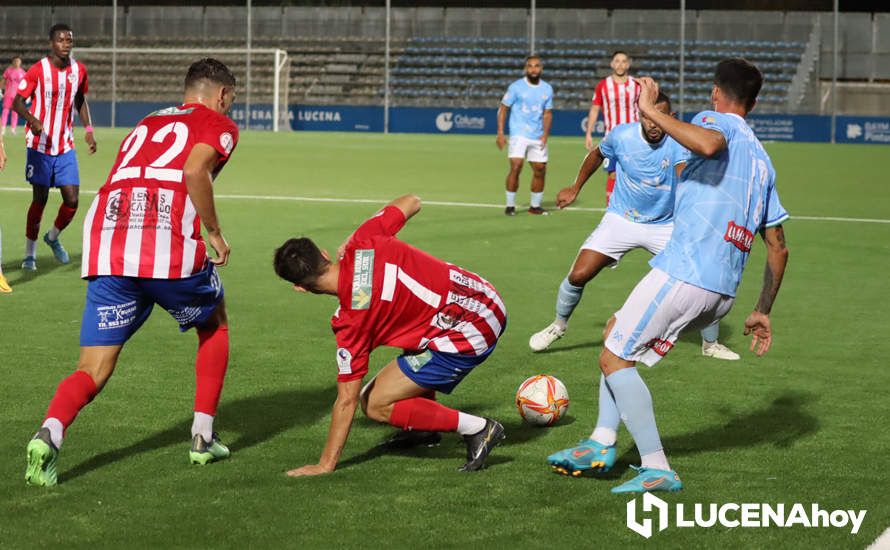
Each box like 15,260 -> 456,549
581,212 -> 674,262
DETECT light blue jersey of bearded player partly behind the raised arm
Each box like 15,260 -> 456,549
599,122 -> 689,223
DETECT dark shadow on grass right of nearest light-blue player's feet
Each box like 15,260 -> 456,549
597,392 -> 819,478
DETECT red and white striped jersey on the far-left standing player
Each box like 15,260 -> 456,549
19,57 -> 89,155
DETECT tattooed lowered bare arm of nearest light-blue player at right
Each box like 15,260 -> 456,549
745,225 -> 788,355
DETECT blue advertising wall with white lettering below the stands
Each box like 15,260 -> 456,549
90,101 -> 890,144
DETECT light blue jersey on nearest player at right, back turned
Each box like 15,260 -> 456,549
649,111 -> 788,296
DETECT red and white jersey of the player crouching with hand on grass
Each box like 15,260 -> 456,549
331,206 -> 507,382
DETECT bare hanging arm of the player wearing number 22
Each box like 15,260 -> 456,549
182,143 -> 230,266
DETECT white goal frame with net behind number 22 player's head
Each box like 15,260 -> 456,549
73,47 -> 291,132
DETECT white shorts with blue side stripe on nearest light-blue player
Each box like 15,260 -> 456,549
605,269 -> 735,367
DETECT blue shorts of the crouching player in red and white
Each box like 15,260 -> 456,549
397,343 -> 497,393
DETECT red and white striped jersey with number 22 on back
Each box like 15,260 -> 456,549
81,103 -> 238,279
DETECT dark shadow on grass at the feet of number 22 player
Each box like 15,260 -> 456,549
61,389 -> 334,481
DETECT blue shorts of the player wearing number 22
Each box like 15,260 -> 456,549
80,262 -> 224,346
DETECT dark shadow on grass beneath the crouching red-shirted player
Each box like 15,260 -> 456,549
337,403 -> 556,470
